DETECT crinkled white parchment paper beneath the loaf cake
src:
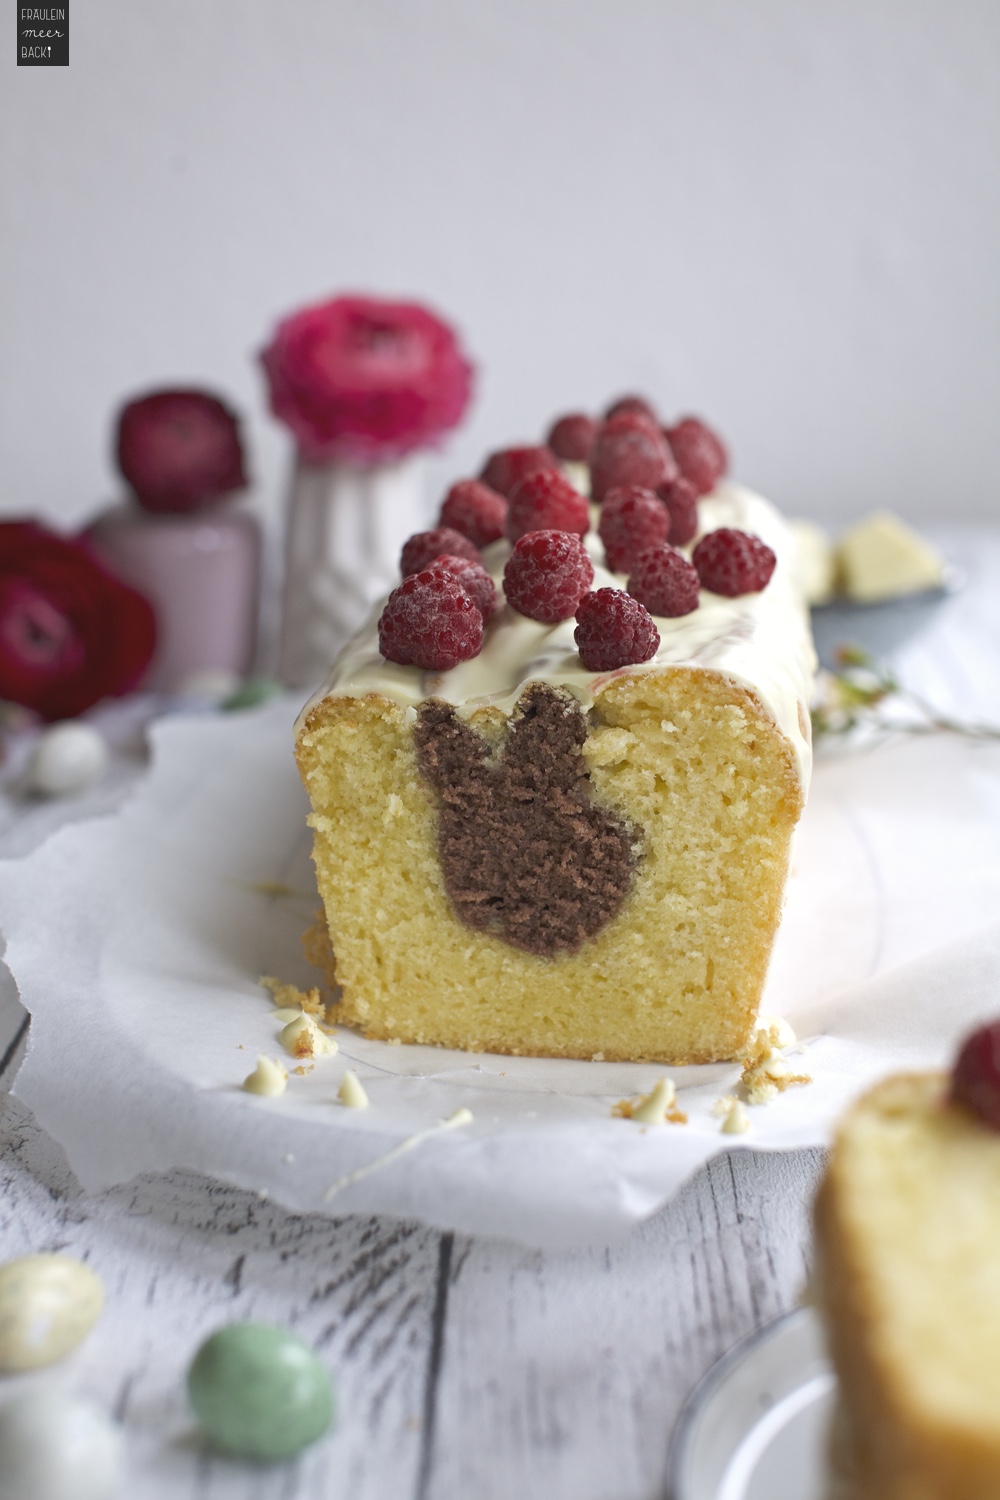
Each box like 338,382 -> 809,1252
0,701 -> 1000,1247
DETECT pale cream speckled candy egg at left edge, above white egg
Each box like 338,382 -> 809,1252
0,1256 -> 103,1374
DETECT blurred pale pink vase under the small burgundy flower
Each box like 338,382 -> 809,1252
87,503 -> 261,693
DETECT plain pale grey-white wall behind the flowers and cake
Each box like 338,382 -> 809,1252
0,0 -> 1000,537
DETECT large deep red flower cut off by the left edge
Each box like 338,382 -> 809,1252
0,521 -> 156,719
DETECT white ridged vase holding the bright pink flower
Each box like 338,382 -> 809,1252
277,456 -> 424,687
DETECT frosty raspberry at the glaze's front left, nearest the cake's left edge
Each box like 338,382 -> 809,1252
378,572 -> 483,672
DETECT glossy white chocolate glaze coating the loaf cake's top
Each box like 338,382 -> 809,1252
297,482 -> 816,786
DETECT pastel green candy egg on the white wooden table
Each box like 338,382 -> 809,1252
187,1323 -> 334,1458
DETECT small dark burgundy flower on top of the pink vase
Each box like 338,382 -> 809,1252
117,390 -> 246,512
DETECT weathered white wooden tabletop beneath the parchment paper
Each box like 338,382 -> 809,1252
0,528 -> 1000,1500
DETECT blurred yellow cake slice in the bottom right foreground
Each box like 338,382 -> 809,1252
814,1028 -> 1000,1500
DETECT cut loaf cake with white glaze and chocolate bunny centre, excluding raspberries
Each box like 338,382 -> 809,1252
297,411 -> 814,1064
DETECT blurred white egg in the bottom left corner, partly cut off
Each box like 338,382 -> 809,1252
0,1391 -> 121,1500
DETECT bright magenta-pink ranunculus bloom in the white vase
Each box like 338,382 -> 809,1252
261,297 -> 472,464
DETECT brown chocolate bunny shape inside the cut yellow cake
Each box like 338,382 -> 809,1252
414,683 -> 636,957
